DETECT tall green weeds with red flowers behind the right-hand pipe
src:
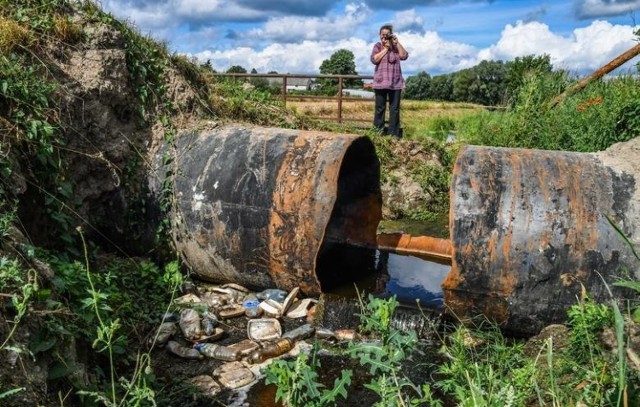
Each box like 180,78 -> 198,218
457,74 -> 640,152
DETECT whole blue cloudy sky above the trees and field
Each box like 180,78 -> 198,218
101,0 -> 640,77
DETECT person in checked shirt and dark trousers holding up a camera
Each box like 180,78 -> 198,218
371,24 -> 409,138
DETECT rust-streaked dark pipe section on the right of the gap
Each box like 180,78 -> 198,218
443,146 -> 640,334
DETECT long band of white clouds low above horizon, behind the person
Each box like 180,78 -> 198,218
195,21 -> 635,77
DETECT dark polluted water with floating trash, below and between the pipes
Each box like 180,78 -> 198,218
152,242 -> 450,407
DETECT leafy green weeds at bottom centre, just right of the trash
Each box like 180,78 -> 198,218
265,296 -> 442,407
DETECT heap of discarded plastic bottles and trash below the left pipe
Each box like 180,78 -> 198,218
150,284 -> 354,395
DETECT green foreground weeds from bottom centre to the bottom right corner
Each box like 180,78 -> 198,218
267,296 -> 640,407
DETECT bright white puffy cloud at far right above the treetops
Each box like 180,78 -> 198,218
478,21 -> 635,72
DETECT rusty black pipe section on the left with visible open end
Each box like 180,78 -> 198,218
159,127 -> 382,295
